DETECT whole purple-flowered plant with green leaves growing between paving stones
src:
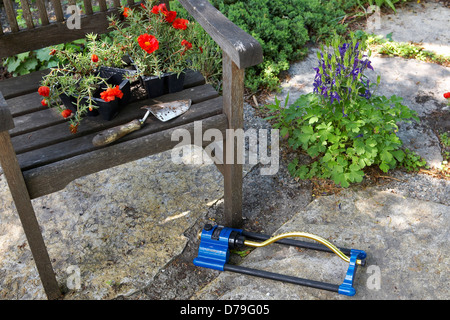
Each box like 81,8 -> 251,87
267,34 -> 424,187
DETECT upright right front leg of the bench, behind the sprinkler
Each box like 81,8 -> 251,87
222,52 -> 244,228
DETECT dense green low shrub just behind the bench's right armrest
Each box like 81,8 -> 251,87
211,0 -> 359,91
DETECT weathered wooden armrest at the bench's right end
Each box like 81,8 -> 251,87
179,0 -> 263,69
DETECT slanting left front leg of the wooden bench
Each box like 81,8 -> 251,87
0,131 -> 61,300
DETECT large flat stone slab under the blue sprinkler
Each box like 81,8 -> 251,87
193,185 -> 450,300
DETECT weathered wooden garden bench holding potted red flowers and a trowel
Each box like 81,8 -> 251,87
0,0 -> 262,299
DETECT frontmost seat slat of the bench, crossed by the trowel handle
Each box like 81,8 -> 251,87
18,98 -> 222,170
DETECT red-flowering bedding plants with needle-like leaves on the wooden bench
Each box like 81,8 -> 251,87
38,0 -> 203,133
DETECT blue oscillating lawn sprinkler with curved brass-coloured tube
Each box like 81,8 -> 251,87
194,224 -> 366,296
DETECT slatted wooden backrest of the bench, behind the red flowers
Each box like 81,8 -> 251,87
0,0 -> 168,59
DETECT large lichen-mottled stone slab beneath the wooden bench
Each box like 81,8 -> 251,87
0,152 -> 223,300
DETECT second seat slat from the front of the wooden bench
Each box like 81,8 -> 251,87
13,85 -> 218,154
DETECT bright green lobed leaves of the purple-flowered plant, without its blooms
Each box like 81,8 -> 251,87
267,33 -> 425,187
